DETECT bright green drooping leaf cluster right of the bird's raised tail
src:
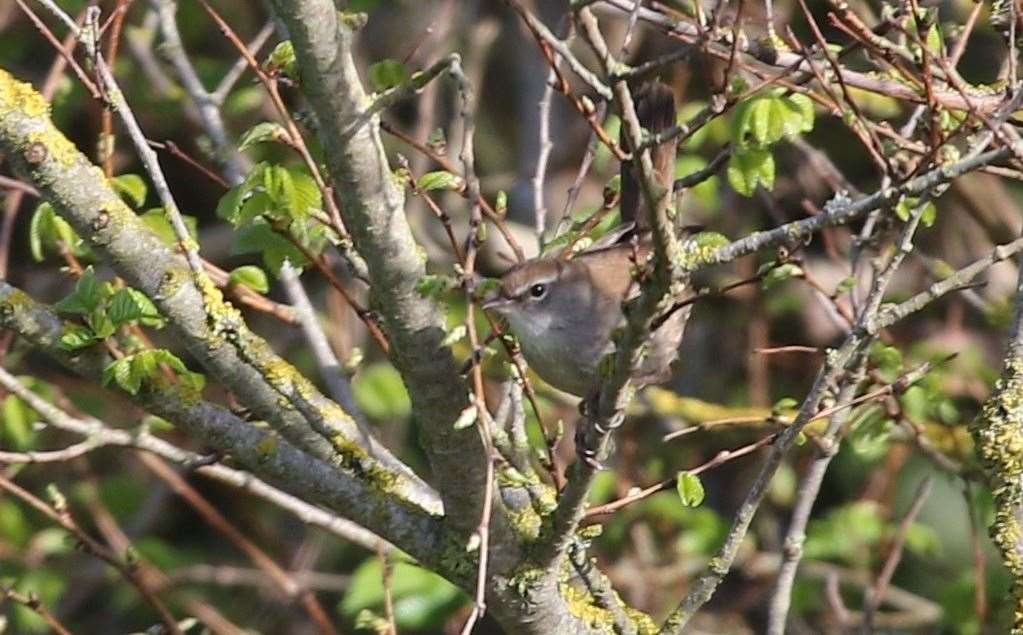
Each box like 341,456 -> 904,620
726,91 -> 813,196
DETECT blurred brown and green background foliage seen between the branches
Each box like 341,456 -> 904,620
0,0 -> 1020,635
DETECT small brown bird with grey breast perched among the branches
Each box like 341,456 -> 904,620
483,83 -> 688,397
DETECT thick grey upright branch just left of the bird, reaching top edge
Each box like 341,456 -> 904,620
273,0 -> 486,535
